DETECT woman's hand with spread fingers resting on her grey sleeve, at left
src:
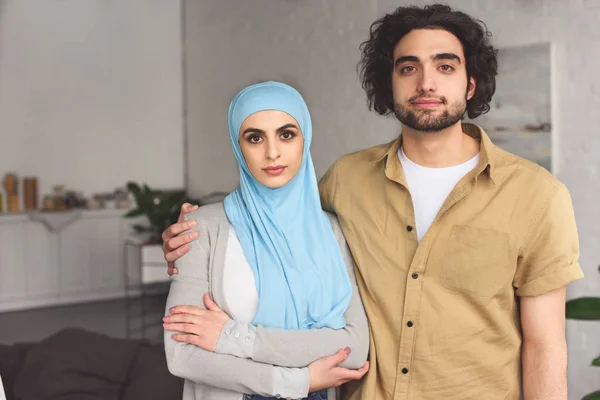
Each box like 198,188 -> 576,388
163,293 -> 229,352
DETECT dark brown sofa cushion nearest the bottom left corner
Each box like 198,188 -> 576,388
14,328 -> 142,400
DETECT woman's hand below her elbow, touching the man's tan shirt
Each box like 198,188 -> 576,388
308,347 -> 369,392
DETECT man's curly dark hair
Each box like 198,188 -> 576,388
358,4 -> 498,118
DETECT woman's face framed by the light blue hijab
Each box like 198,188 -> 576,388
238,110 -> 304,189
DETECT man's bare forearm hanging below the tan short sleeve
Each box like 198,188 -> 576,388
521,287 -> 567,400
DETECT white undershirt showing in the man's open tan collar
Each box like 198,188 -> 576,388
398,148 -> 479,241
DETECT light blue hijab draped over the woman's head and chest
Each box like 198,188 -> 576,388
225,82 -> 352,329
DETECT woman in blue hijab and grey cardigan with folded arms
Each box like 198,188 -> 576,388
164,82 -> 369,400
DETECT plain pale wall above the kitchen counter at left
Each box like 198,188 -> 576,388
0,0 -> 184,202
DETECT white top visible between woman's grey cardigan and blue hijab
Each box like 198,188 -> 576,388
223,225 -> 258,324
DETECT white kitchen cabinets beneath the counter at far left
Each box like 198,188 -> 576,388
0,210 -> 131,312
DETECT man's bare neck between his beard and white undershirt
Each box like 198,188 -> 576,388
402,121 -> 479,168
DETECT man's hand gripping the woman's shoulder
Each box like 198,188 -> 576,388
162,203 -> 198,275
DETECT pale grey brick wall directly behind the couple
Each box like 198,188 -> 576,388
185,0 -> 600,400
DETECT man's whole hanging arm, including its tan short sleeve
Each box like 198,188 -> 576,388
513,184 -> 583,400
